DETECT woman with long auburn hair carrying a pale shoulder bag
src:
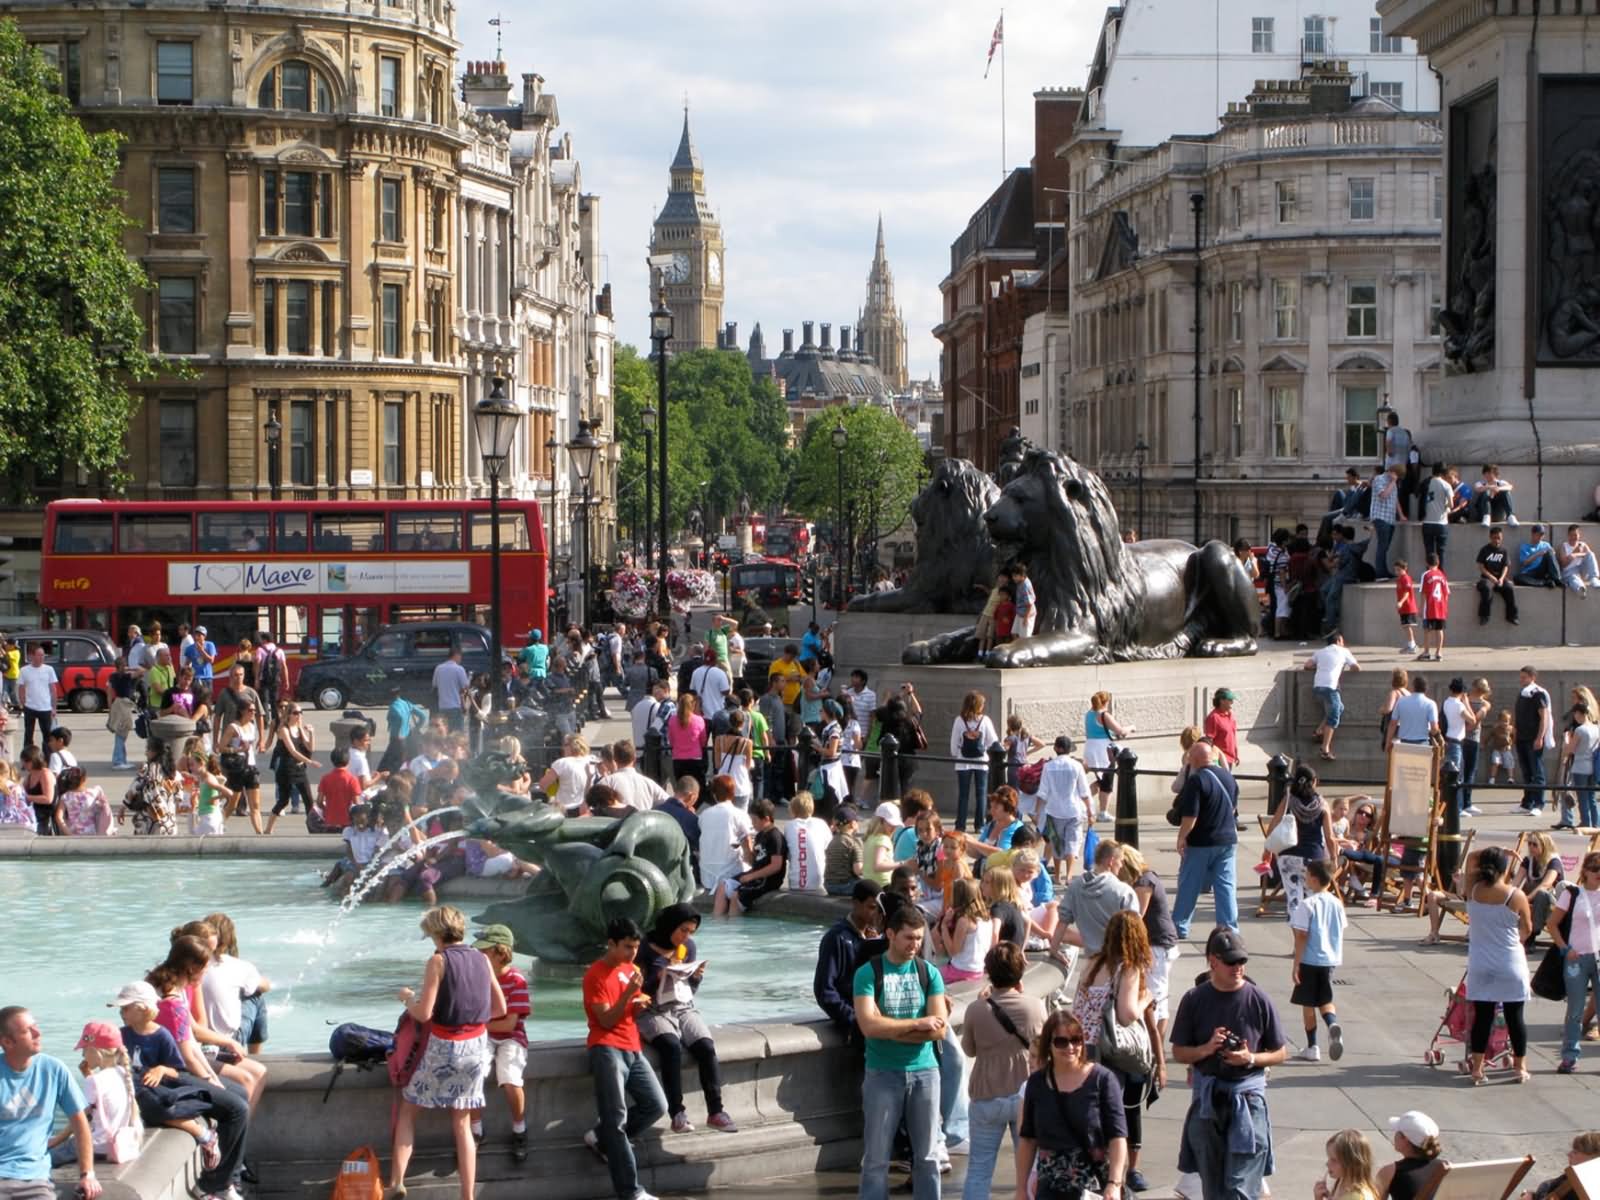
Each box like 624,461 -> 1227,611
1072,909 -> 1166,1192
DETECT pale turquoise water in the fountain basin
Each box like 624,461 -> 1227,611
0,858 -> 821,1061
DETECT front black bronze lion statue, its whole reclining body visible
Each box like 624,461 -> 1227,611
902,450 -> 1261,667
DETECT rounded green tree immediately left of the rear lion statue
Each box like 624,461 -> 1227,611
789,405 -> 926,579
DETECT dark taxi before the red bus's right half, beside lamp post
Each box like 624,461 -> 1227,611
294,621 -> 490,712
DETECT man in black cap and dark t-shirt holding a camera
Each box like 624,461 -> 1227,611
1173,926 -> 1288,1200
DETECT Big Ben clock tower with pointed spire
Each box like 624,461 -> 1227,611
650,107 -> 723,350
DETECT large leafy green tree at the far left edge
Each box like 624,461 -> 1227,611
0,21 -> 157,480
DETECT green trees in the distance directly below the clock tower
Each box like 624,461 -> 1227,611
614,346 -> 790,531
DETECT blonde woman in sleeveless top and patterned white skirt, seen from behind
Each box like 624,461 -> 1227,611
389,904 -> 506,1200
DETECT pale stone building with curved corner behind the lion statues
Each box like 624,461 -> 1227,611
1062,61 -> 1443,541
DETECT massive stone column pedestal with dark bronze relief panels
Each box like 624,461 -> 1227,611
1378,0 -> 1600,520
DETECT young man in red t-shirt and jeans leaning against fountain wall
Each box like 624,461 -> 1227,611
584,917 -> 667,1200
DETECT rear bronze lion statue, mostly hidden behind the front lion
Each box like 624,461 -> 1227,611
850,458 -> 1000,613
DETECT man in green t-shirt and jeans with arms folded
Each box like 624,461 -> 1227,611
851,904 -> 950,1200
